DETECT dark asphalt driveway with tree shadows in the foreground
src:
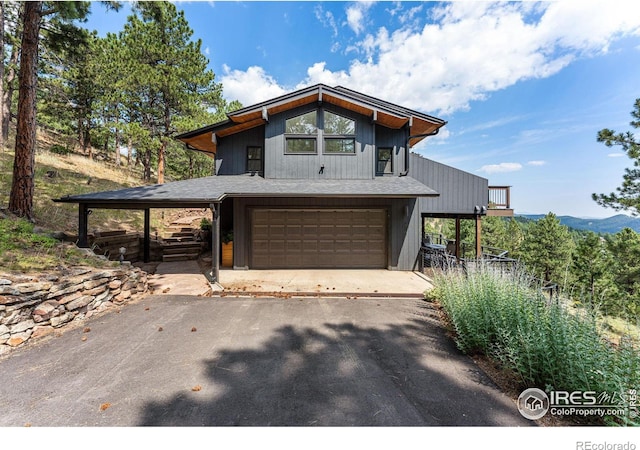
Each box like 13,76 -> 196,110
0,295 -> 532,426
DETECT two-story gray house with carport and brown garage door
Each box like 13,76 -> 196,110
57,84 -> 508,280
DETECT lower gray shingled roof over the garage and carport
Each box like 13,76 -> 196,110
54,175 -> 439,208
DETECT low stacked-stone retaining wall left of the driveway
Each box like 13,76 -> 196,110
0,264 -> 147,355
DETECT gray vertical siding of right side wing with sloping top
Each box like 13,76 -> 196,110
409,153 -> 489,214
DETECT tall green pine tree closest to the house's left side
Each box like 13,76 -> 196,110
121,2 -> 224,183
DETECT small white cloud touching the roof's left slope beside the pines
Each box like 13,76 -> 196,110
220,65 -> 286,106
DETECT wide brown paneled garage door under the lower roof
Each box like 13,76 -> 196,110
251,209 -> 387,269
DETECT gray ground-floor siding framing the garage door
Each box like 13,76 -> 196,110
233,198 -> 421,270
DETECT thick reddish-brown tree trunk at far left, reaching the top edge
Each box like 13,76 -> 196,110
9,2 -> 42,220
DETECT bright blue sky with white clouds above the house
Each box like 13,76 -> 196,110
85,0 -> 640,218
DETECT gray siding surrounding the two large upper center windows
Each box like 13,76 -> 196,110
264,105 -> 375,180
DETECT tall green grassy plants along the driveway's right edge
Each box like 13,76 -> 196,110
431,268 -> 640,424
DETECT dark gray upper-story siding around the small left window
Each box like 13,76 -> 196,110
216,126 -> 265,175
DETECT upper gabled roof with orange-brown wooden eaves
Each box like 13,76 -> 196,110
176,84 -> 446,153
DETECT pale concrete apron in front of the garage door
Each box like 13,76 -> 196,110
220,269 -> 432,298
